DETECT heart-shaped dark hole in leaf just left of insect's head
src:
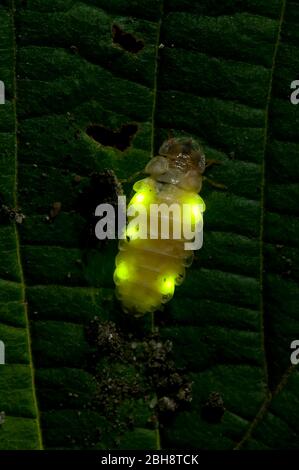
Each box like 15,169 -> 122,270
86,124 -> 138,152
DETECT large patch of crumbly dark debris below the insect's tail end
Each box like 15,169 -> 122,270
87,318 -> 192,442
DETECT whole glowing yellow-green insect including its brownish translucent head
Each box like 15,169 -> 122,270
114,139 -> 205,316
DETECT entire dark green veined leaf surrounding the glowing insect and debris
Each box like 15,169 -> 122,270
0,0 -> 299,449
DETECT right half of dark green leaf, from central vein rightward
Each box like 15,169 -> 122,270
157,0 -> 299,449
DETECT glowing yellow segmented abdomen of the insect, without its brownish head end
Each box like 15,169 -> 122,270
114,178 -> 204,316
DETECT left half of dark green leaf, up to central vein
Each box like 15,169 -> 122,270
0,1 -> 162,449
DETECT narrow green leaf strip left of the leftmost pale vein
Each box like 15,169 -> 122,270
0,4 -> 41,449
